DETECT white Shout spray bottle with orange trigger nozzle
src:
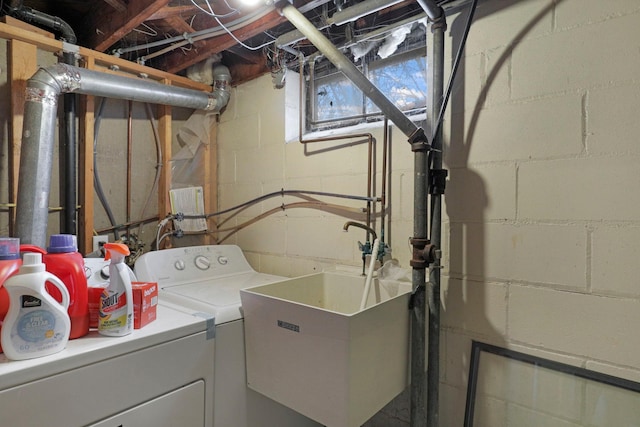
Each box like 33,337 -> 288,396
98,243 -> 133,337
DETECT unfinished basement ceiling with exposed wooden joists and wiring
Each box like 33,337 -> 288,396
4,0 -> 460,85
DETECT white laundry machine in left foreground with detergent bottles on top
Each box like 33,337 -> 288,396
0,300 -> 214,427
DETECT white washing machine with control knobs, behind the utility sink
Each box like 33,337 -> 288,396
134,245 -> 321,427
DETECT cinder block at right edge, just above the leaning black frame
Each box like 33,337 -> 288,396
508,285 -> 640,369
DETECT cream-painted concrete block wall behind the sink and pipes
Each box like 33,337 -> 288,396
219,0 -> 640,427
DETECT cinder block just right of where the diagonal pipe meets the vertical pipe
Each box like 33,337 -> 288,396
447,94 -> 583,167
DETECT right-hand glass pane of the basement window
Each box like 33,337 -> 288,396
366,56 -> 427,114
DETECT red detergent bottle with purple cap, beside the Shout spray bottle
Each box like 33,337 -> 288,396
42,234 -> 89,339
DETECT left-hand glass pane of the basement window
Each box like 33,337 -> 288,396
314,73 -> 363,122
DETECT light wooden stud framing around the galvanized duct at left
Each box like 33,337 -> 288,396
0,22 -> 217,253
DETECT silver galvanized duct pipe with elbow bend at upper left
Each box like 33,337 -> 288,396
16,64 -> 231,247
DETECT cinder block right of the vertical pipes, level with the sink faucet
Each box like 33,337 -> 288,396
449,223 -> 587,289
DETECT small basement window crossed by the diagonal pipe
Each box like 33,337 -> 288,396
306,23 -> 427,132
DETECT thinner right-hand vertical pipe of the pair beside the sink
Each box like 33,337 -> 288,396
427,14 -> 446,427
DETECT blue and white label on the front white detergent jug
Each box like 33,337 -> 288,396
11,295 -> 64,353
